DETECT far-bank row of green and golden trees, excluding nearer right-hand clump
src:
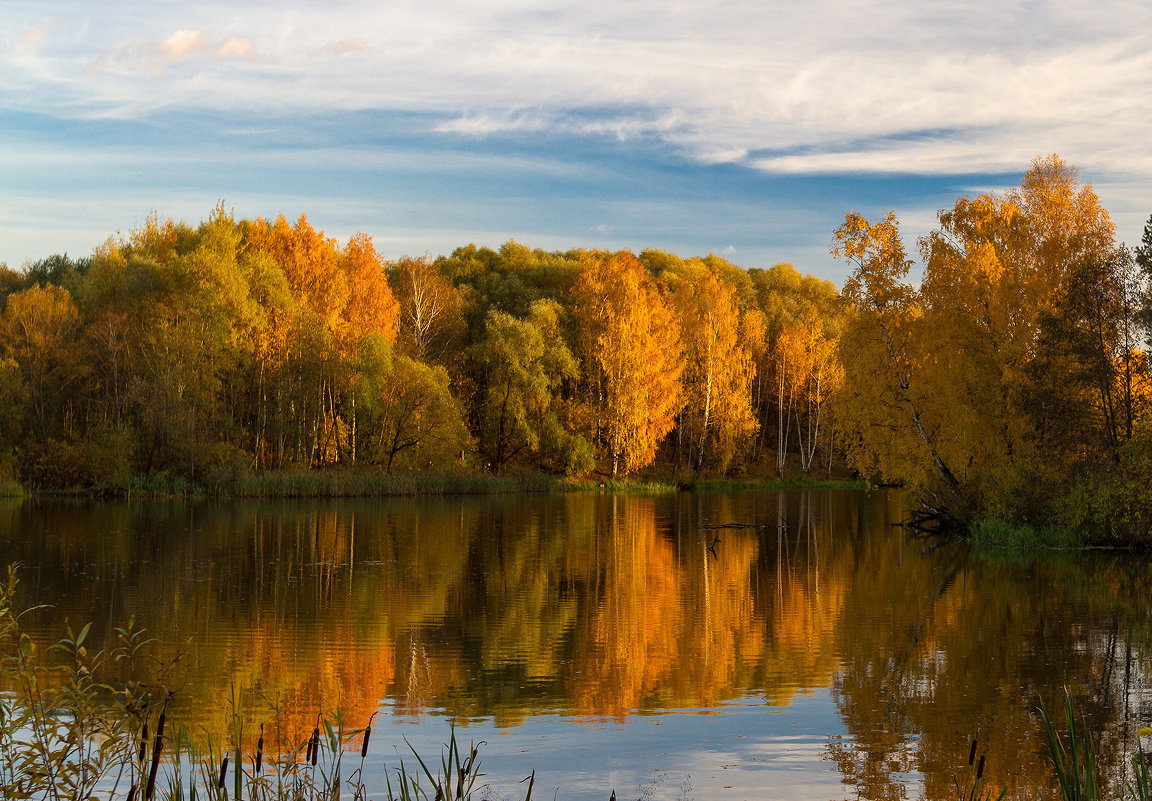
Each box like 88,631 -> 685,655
0,207 -> 843,488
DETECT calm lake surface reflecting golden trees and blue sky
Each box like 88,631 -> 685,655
0,491 -> 1152,801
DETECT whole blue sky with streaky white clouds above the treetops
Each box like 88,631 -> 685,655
0,0 -> 1152,284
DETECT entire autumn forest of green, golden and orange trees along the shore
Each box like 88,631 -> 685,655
0,156 -> 1152,545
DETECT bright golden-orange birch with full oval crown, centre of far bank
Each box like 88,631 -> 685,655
574,250 -> 683,476
